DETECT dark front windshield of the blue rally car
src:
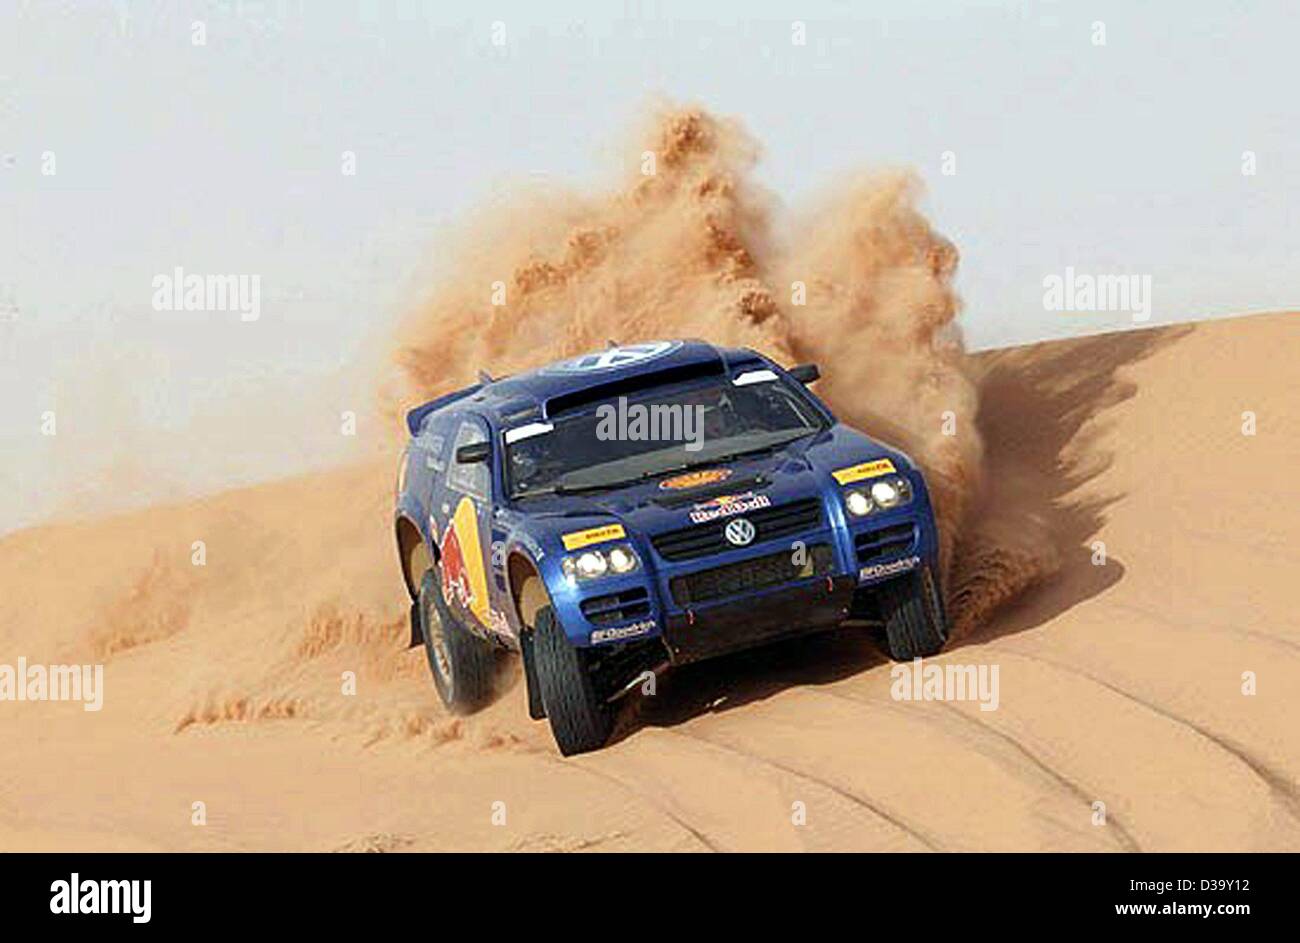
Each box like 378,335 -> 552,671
506,379 -> 824,498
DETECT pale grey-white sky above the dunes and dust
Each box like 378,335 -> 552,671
0,0 -> 1300,532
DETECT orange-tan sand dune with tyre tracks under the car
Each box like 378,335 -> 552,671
0,315 -> 1300,851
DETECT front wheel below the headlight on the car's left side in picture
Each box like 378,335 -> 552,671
533,606 -> 614,756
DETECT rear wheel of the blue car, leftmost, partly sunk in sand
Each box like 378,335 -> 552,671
416,566 -> 497,714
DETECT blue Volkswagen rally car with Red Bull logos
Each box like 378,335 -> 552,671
395,341 -> 948,756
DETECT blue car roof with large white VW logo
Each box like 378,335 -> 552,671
426,339 -> 770,425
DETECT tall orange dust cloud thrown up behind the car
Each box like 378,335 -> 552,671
389,108 -> 1054,630
